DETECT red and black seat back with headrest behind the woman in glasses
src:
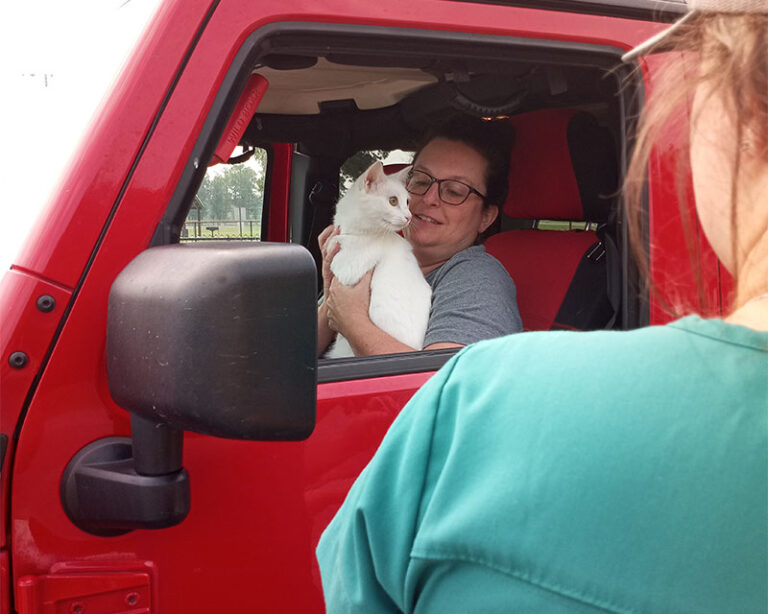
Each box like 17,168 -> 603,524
485,109 -> 619,330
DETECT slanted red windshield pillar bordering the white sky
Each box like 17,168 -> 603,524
16,0 -> 212,287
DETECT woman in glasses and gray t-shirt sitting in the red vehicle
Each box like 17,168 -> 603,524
318,119 -> 522,356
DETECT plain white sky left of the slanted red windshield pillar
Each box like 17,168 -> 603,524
0,0 -> 160,277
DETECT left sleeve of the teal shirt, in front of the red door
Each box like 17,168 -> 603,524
317,352 -> 462,614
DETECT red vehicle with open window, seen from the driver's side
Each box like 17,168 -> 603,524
0,0 -> 729,613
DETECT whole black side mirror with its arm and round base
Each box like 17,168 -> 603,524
61,242 -> 317,536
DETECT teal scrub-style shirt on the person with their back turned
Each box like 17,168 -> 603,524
317,317 -> 768,614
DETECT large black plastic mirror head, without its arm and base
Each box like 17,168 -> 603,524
107,242 -> 317,441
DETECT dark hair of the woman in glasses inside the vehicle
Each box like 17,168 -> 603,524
413,116 -> 514,209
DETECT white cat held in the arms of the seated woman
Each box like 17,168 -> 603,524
325,162 -> 432,358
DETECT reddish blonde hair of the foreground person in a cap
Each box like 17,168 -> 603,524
625,13 -> 768,311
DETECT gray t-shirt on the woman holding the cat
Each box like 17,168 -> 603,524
424,245 -> 523,347
